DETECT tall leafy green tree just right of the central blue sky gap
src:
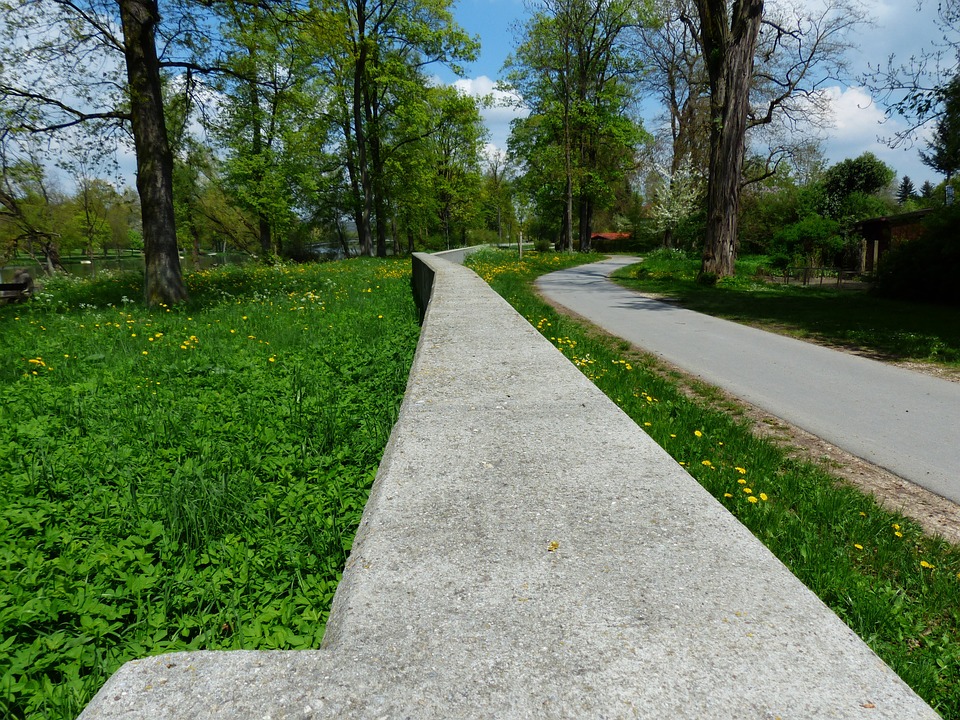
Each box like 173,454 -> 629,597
506,0 -> 646,251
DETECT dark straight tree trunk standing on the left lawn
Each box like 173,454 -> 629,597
119,0 -> 187,305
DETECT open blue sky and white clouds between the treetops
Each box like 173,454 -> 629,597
444,0 -> 942,187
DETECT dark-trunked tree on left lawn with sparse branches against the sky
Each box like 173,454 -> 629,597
0,0 -> 186,305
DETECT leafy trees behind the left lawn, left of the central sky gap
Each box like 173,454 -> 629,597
0,0 -> 515,303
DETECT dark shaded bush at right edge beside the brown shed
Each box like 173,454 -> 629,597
874,205 -> 960,305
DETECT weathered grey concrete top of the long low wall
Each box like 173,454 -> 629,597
81,258 -> 937,720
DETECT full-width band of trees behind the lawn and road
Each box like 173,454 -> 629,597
0,0 -> 960,303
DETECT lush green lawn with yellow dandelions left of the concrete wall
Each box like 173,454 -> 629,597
0,260 -> 418,720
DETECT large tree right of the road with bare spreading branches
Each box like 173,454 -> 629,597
644,0 -> 863,277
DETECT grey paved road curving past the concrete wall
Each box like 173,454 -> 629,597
537,257 -> 960,503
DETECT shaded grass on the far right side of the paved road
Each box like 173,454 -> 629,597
614,250 -> 960,369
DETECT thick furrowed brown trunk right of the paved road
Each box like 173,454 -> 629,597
697,0 -> 763,278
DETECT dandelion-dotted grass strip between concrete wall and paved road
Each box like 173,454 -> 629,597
468,252 -> 960,719
